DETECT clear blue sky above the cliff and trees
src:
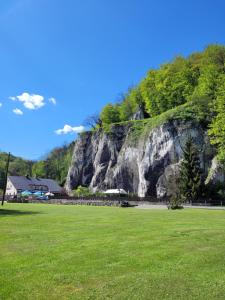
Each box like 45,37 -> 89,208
0,0 -> 225,159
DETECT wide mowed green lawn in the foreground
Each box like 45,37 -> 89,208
0,204 -> 225,300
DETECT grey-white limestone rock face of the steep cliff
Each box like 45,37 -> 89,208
65,120 -> 214,197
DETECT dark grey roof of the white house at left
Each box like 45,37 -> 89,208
8,176 -> 62,193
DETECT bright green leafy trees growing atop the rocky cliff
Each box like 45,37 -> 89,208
100,45 -> 225,126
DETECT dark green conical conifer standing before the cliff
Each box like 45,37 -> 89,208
179,137 -> 202,201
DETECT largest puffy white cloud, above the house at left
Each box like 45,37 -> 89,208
9,93 -> 45,109
